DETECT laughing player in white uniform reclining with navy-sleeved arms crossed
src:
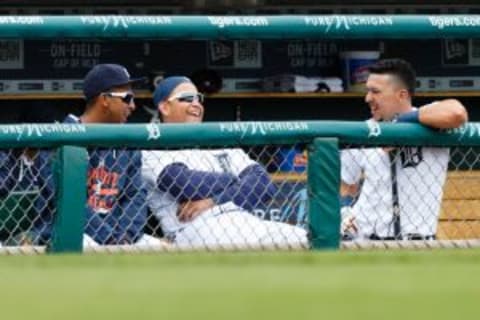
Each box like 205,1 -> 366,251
142,77 -> 308,249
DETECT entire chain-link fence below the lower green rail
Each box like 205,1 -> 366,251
0,145 -> 480,253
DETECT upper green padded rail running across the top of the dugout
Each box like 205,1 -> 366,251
0,15 -> 480,40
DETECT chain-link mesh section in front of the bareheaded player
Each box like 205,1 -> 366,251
341,146 -> 480,248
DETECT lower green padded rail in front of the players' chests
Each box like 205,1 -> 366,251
0,121 -> 480,149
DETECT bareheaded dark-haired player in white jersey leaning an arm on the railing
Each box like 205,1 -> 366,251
341,59 -> 468,240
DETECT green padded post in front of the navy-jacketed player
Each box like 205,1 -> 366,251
47,146 -> 88,253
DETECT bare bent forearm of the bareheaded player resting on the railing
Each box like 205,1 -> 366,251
418,99 -> 468,129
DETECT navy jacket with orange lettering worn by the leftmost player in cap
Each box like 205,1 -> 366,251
36,115 -> 147,244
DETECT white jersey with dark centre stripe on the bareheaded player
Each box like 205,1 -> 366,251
341,147 -> 449,237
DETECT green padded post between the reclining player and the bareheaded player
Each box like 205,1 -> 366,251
307,138 -> 340,250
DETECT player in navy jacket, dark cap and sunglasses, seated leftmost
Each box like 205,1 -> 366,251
31,64 -> 147,244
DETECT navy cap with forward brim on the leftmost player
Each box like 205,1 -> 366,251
83,64 -> 145,100
